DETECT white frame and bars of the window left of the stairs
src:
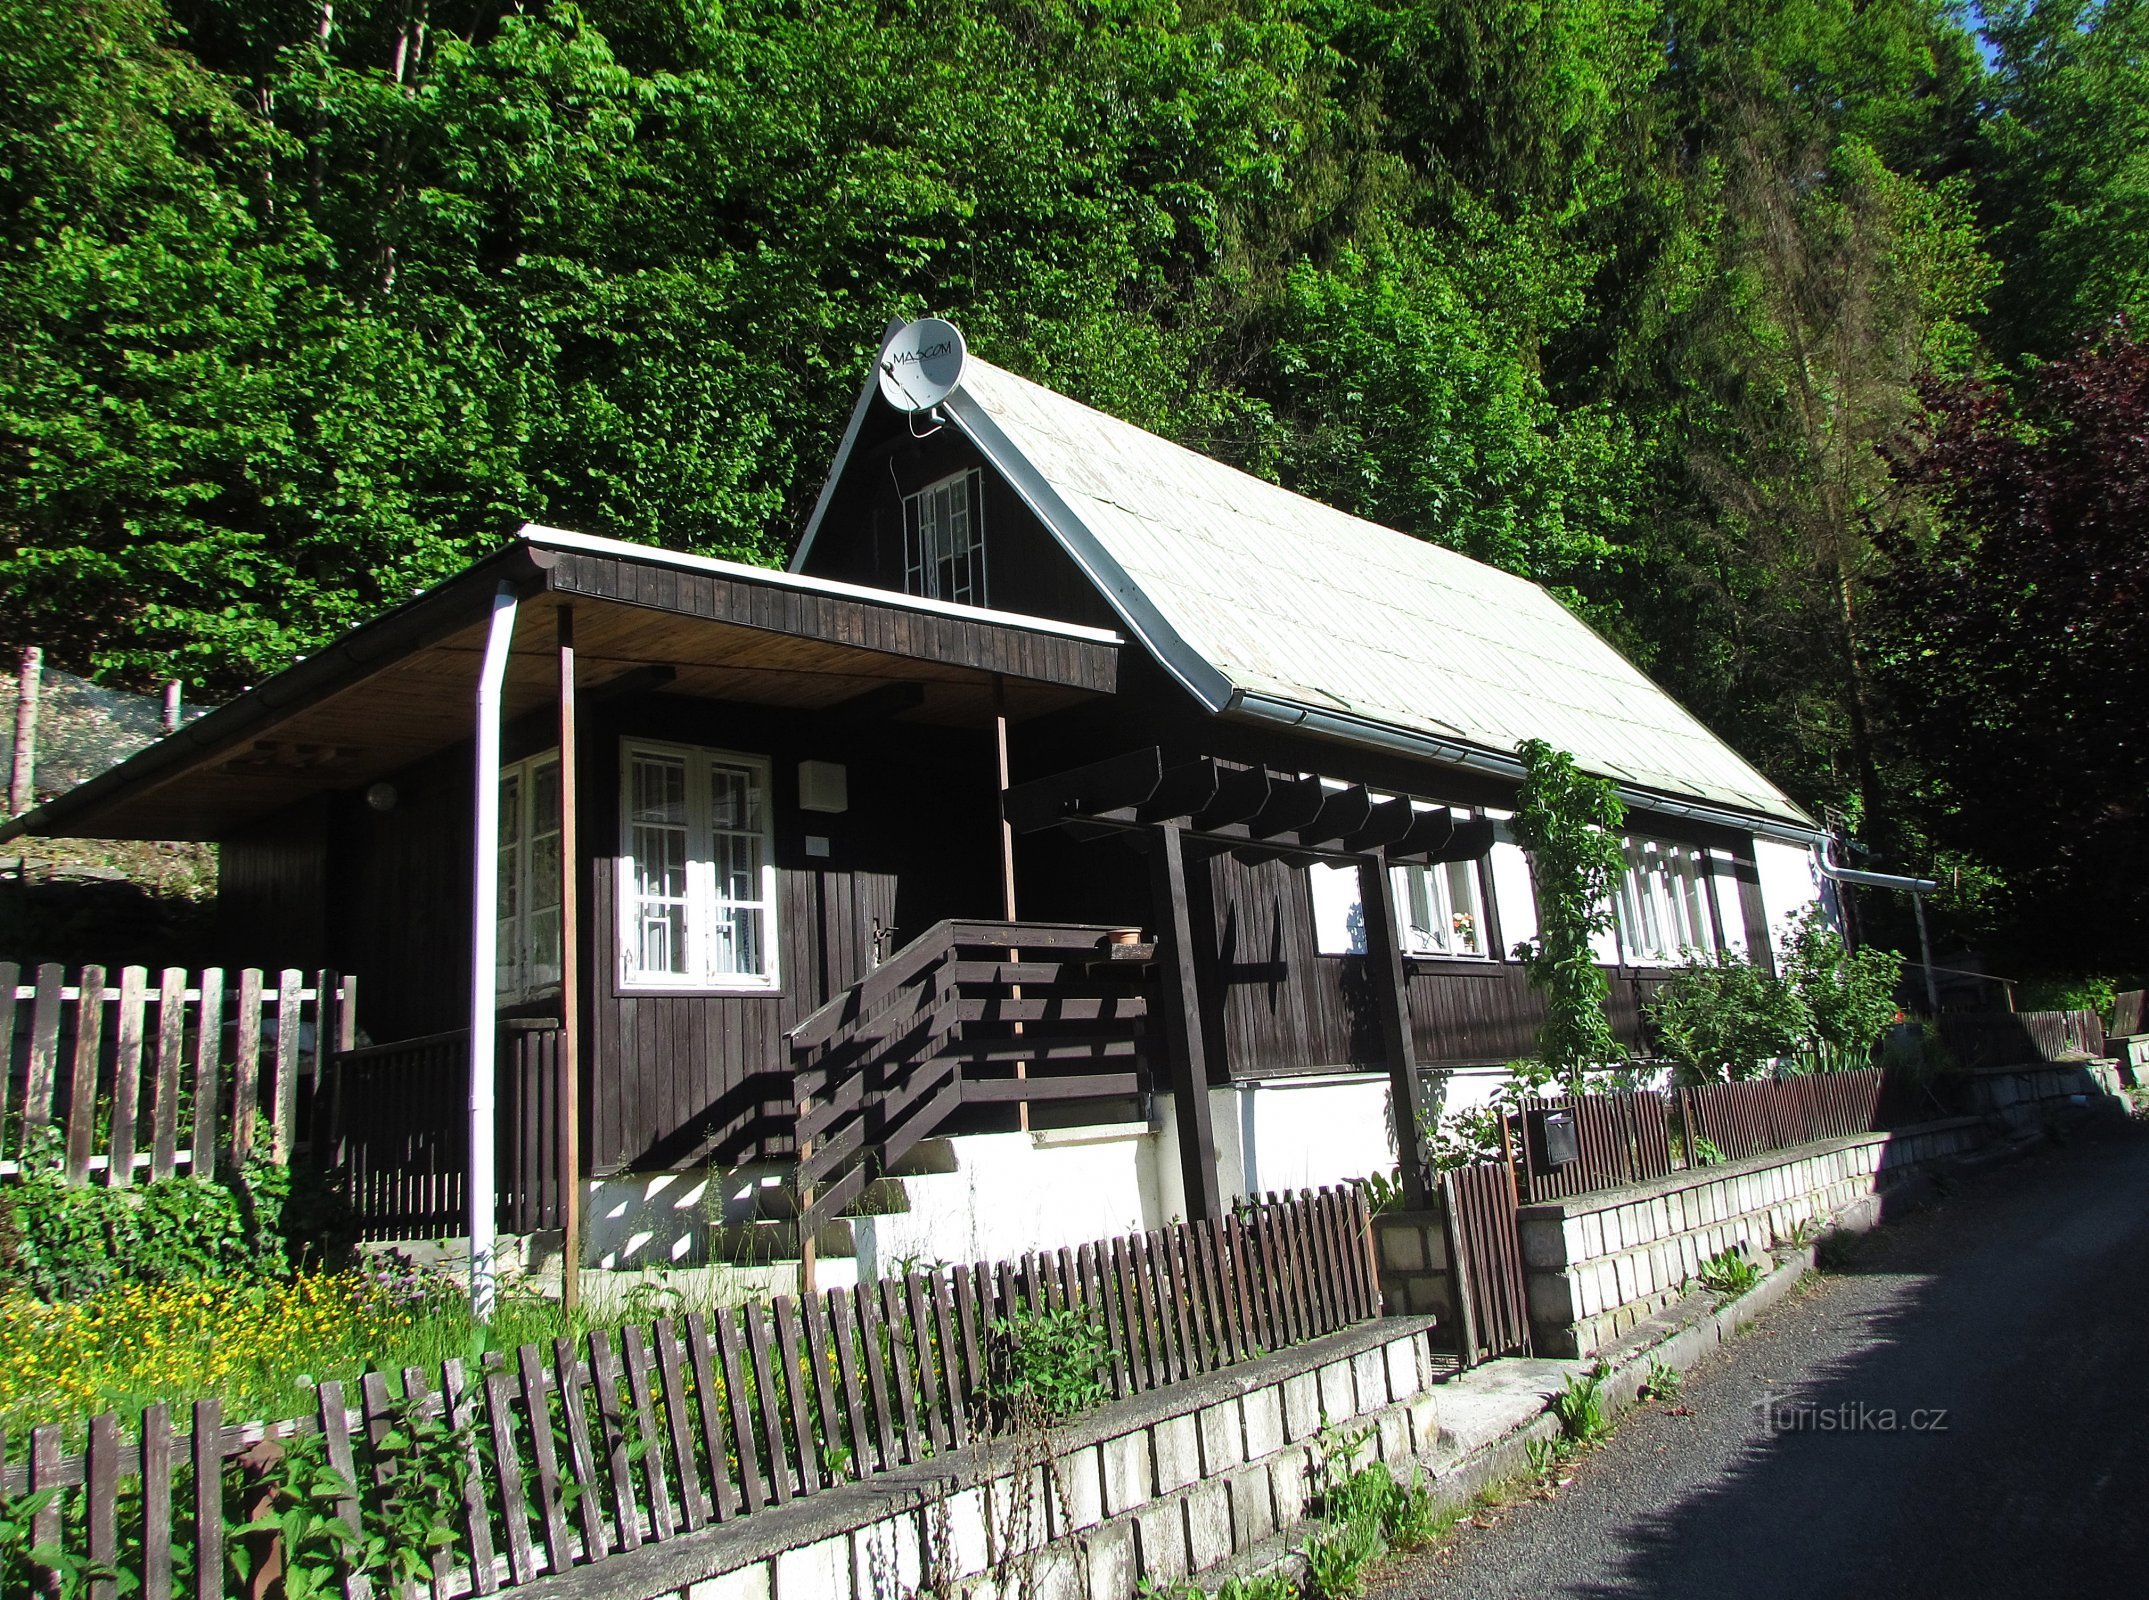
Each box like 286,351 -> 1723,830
617,739 -> 782,994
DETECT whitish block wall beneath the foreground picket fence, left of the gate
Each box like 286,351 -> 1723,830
614,1319 -> 1440,1600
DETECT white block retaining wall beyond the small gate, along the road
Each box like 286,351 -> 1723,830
1517,1117 -> 1988,1355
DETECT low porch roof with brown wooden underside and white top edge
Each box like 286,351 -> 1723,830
0,524 -> 1120,842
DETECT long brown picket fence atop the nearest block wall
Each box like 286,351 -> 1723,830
0,1190 -> 1378,1600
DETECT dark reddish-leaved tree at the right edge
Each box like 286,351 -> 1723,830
1880,333 -> 2149,971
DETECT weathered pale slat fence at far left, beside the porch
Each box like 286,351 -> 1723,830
0,962 -> 357,1183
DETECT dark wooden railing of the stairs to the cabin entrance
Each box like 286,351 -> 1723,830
789,921 -> 1152,1235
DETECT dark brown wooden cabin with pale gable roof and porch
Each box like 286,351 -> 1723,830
9,328 -> 1818,1274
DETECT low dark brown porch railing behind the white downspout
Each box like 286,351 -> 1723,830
324,1018 -> 563,1239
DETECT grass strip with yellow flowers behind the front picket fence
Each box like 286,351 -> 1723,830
0,1265 -> 756,1437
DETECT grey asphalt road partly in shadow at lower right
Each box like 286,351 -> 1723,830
1375,1128 -> 2149,1600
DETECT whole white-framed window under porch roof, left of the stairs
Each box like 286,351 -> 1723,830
619,739 -> 778,990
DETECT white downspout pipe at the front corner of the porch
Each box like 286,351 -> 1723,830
468,584 -> 516,1323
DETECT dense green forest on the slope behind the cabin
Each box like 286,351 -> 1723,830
0,0 -> 2149,973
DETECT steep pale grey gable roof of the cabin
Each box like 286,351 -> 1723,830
793,337 -> 1814,838
